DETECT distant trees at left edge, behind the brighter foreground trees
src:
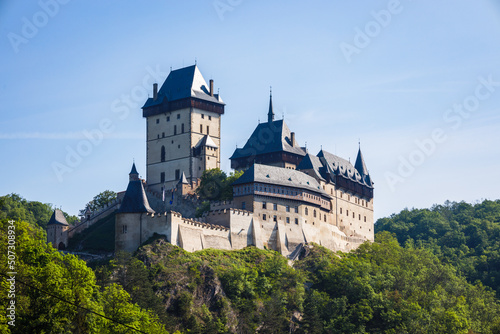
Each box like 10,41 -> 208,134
0,194 -> 78,229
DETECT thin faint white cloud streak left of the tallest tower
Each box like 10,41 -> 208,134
0,132 -> 144,140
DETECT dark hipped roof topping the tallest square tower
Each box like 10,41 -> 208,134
143,65 -> 224,108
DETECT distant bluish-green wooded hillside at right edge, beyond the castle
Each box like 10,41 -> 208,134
375,200 -> 500,296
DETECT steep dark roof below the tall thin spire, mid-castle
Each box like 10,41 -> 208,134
230,120 -> 306,159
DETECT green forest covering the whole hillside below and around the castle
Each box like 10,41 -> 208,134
0,195 -> 500,334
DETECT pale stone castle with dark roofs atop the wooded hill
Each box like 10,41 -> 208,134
47,65 -> 374,257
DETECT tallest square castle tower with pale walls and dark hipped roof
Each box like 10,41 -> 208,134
142,65 -> 225,192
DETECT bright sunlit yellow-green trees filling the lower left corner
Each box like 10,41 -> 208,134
0,219 -> 165,333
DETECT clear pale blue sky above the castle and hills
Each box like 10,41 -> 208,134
0,0 -> 500,218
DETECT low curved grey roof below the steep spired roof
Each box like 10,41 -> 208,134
233,164 -> 330,197
